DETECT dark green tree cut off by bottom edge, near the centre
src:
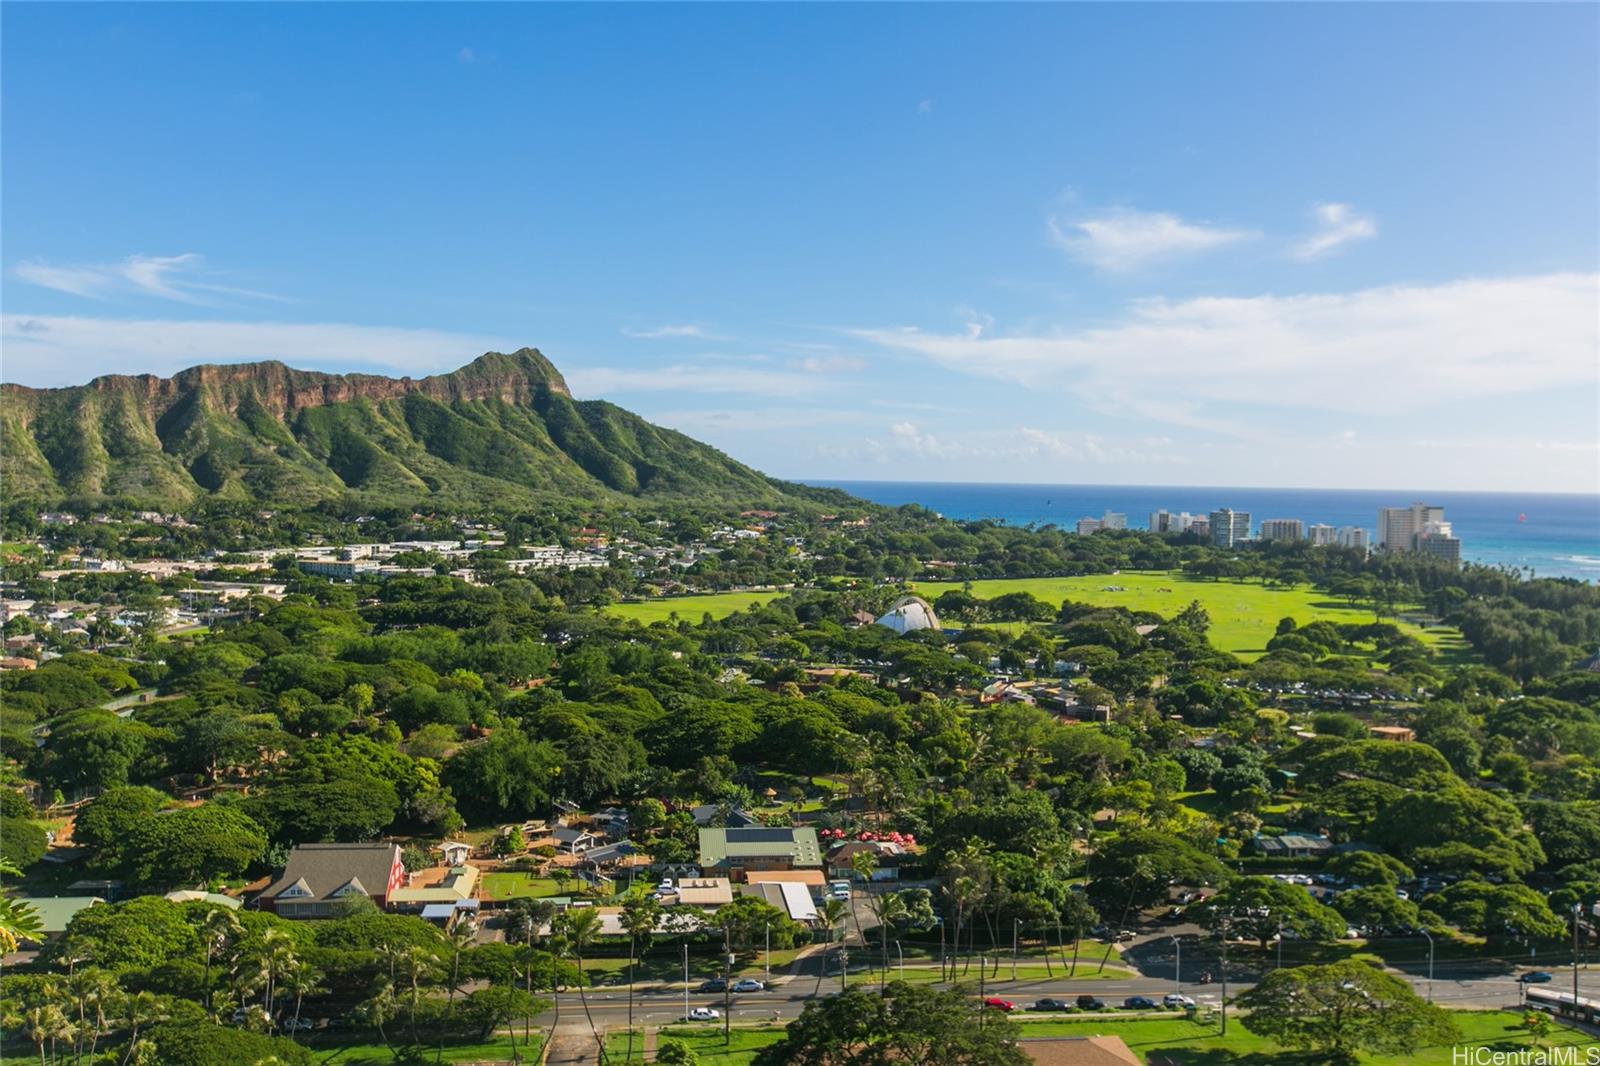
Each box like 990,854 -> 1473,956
755,981 -> 1030,1066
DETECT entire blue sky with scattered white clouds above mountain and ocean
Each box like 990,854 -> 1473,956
0,3 -> 1600,491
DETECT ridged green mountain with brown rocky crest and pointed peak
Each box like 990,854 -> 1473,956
0,349 -> 837,507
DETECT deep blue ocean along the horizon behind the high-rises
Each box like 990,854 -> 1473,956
808,482 -> 1600,583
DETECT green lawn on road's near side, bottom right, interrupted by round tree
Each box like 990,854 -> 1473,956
1019,1010 -> 1600,1066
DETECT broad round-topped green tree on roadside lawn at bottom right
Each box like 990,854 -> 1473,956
1235,960 -> 1458,1063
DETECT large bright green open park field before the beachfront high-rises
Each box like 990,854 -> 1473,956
917,571 -> 1466,659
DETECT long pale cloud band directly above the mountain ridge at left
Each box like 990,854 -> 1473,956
0,314 -> 517,386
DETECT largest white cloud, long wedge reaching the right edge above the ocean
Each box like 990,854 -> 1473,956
856,274 -> 1600,429
